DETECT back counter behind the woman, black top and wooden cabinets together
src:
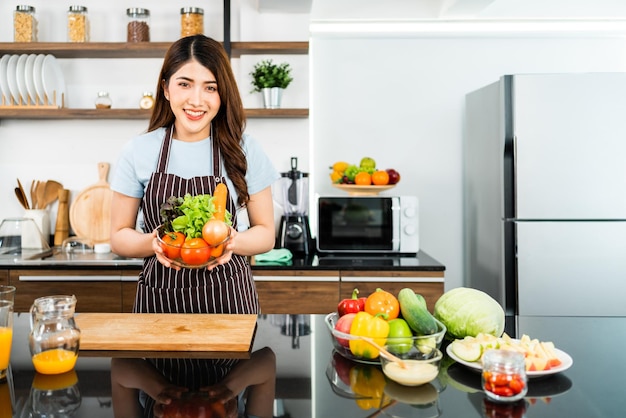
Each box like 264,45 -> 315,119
0,251 -> 445,314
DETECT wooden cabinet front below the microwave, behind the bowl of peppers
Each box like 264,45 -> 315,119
340,271 -> 444,312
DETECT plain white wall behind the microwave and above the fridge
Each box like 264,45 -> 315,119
311,17 -> 626,288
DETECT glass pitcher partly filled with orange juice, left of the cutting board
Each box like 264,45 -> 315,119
28,295 -> 80,374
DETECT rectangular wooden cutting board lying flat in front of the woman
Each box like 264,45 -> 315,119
75,313 -> 257,358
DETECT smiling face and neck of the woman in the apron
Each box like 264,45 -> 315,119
163,60 -> 221,142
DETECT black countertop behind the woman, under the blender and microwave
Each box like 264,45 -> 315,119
0,251 -> 445,272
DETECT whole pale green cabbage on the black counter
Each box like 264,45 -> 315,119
433,287 -> 504,339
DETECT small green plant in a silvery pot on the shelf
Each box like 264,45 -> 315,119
250,59 -> 293,109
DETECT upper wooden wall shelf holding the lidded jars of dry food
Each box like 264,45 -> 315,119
0,42 -> 309,58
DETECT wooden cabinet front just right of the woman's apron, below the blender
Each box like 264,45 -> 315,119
254,270 -> 339,314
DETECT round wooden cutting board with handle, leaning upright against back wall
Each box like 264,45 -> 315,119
70,163 -> 113,244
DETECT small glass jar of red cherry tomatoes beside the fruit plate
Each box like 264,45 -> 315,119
482,349 -> 528,402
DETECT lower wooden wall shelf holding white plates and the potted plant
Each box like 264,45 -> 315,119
0,107 -> 309,119
